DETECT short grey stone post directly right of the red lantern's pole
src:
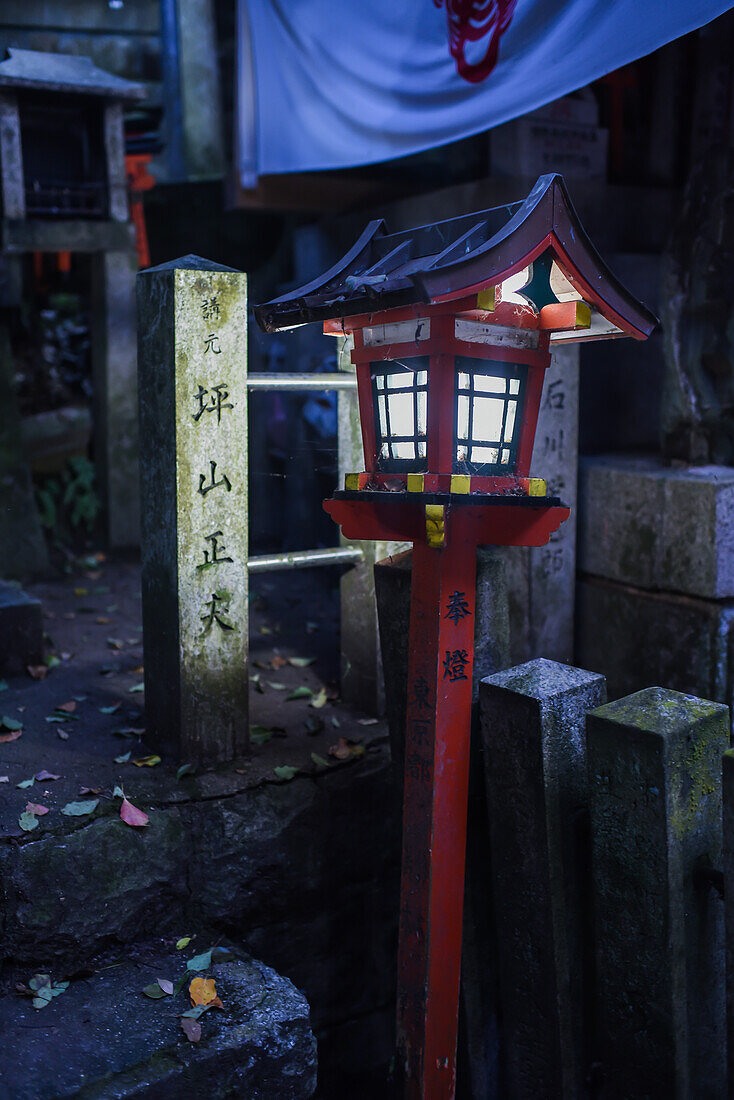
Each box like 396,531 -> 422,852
480,658 -> 606,1100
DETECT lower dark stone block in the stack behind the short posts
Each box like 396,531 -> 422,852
576,578 -> 734,702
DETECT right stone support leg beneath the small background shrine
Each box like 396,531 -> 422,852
91,251 -> 140,547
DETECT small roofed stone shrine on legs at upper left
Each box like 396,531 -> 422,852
0,48 -> 145,546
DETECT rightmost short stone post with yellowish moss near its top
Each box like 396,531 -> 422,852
587,688 -> 728,1100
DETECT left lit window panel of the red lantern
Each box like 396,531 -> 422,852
370,355 -> 428,471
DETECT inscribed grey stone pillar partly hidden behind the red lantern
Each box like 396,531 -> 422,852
502,344 -> 579,663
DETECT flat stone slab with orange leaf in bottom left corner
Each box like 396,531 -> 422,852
0,953 -> 316,1100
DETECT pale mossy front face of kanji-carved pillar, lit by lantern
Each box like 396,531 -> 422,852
175,268 -> 248,759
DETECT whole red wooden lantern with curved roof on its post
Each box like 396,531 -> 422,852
255,175 -> 656,1100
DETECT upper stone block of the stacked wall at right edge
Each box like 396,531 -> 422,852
579,455 -> 734,600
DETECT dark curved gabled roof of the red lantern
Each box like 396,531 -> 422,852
255,173 -> 657,341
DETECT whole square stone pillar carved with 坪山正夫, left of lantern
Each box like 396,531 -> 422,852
138,256 -> 249,763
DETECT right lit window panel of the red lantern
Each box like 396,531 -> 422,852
453,355 -> 527,475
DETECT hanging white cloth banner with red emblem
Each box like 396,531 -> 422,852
238,0 -> 733,187
